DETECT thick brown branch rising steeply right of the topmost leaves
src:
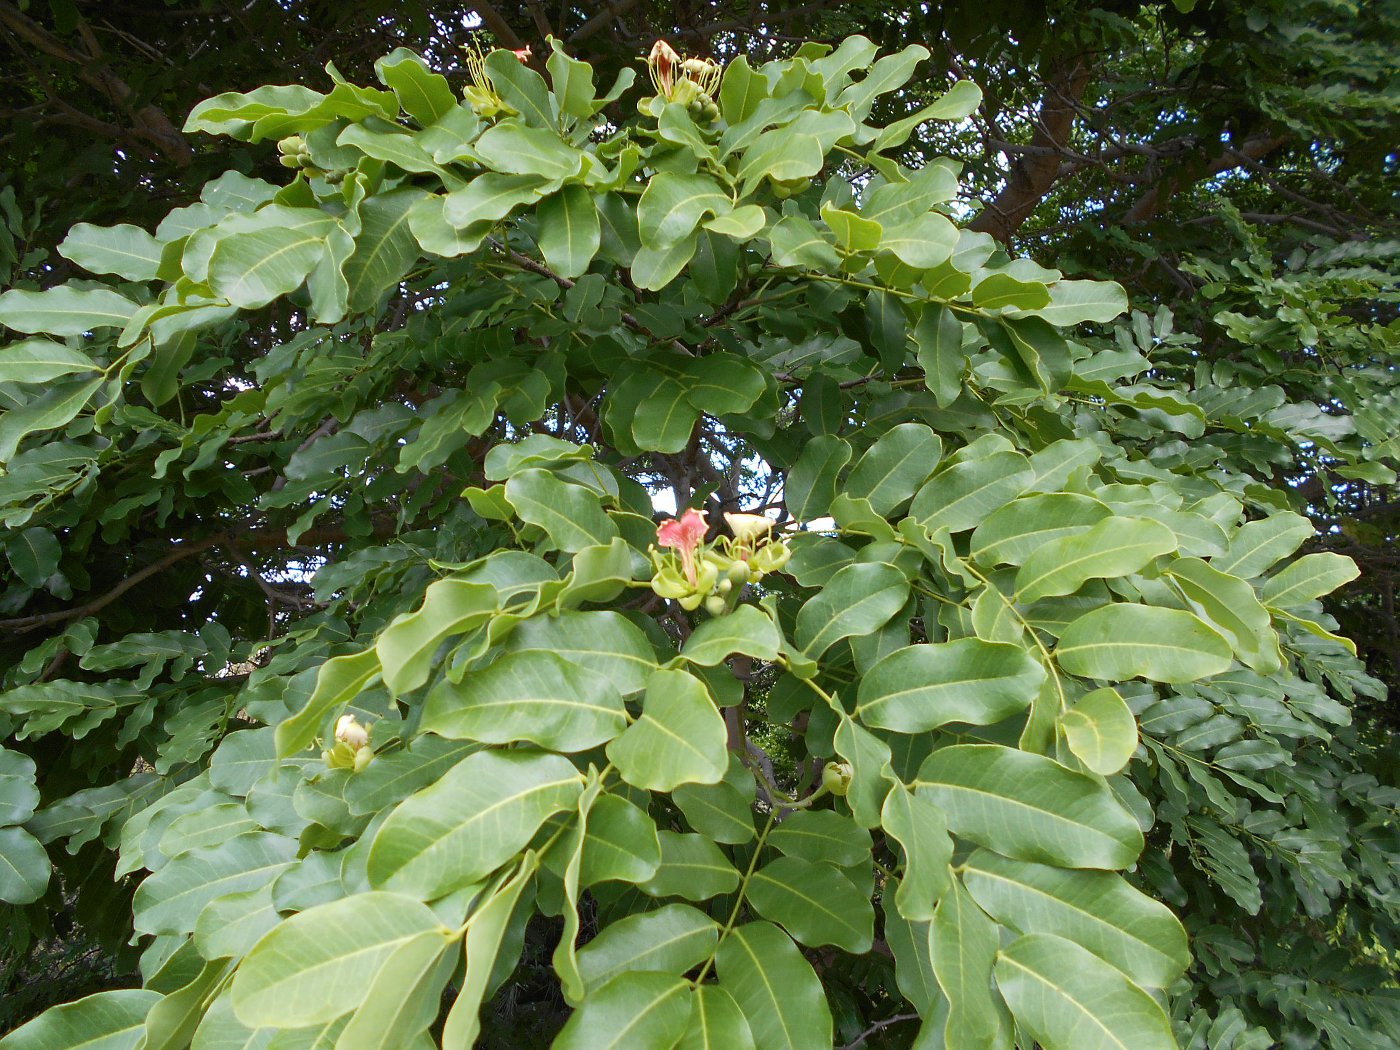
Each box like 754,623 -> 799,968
967,53 -> 1092,244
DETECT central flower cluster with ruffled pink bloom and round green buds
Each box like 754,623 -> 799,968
651,510 -> 791,616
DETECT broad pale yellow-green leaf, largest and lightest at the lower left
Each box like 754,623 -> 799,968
230,893 -> 451,1029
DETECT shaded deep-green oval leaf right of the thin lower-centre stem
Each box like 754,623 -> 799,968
746,857 -> 875,955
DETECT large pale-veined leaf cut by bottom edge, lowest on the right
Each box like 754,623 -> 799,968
997,934 -> 1176,1050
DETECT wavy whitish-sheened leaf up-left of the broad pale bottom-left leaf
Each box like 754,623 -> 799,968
132,832 -> 297,934
